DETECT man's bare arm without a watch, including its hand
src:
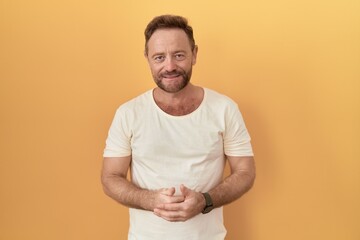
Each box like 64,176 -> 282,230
101,156 -> 184,211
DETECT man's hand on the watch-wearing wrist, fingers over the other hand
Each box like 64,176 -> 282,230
154,185 -> 205,222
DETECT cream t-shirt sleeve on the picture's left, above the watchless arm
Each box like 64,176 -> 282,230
103,107 -> 131,157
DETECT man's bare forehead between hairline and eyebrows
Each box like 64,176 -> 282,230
148,28 -> 191,53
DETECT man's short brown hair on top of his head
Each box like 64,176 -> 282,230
144,15 -> 195,54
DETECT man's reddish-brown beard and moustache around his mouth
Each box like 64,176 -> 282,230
153,69 -> 192,93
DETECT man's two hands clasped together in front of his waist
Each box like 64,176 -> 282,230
154,185 -> 205,222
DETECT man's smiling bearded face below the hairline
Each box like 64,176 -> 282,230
146,29 -> 197,93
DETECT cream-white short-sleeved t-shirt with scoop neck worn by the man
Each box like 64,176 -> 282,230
104,88 -> 253,240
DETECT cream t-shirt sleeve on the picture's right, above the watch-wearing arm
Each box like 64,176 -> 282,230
224,103 -> 254,157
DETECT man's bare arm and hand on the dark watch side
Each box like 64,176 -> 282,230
154,156 -> 255,222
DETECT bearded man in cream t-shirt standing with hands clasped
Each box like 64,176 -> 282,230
102,15 -> 255,240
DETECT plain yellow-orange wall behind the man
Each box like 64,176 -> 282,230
0,0 -> 360,240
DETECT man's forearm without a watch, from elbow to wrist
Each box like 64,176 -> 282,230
102,175 -> 154,211
